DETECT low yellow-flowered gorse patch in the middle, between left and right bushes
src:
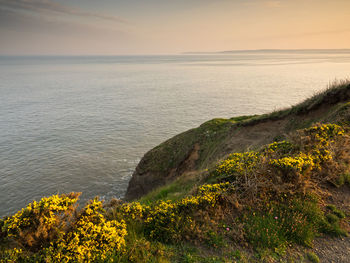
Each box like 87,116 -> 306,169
110,182 -> 230,243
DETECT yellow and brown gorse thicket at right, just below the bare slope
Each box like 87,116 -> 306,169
211,124 -> 349,200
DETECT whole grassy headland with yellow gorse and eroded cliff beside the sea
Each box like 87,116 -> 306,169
0,82 -> 350,262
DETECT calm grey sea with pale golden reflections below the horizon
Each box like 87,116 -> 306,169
0,52 -> 350,216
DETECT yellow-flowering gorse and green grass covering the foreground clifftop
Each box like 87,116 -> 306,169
0,83 -> 350,262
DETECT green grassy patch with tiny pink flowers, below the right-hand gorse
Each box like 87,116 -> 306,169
243,195 -> 346,255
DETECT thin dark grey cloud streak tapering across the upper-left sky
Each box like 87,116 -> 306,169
0,0 -> 126,23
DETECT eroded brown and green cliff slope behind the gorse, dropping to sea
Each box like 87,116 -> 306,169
125,81 -> 350,200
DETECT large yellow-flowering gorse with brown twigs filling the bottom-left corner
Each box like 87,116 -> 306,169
1,193 -> 127,262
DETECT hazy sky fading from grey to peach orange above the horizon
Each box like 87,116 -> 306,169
0,0 -> 350,55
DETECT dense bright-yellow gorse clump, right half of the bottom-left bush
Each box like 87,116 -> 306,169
44,199 -> 127,262
